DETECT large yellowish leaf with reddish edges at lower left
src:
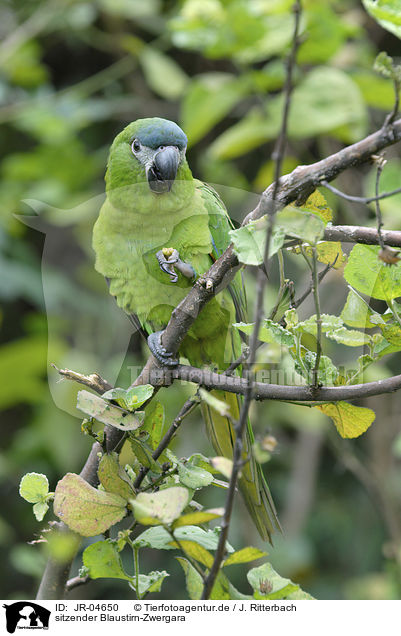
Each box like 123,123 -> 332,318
54,473 -> 127,537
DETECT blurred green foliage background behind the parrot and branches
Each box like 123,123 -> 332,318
0,0 -> 401,599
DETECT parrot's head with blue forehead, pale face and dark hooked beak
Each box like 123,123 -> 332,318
106,117 -> 192,200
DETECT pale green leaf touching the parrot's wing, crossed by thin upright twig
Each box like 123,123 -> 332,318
229,217 -> 285,265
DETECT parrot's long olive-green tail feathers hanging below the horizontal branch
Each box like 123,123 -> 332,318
202,391 -> 282,543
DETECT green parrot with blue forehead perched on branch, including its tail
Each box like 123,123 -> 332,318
93,117 -> 280,541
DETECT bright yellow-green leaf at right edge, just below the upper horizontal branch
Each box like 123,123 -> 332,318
344,245 -> 401,302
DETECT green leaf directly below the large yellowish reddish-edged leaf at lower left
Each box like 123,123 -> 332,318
82,539 -> 132,581
